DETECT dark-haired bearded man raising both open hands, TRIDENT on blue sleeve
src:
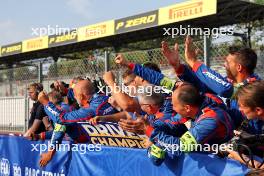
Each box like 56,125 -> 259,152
166,36 -> 264,134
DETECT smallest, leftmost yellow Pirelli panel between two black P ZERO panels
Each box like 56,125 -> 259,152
22,36 -> 48,53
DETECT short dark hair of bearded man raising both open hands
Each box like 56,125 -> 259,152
229,46 -> 258,74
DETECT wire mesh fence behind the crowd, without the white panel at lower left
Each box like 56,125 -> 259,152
0,41 -> 264,97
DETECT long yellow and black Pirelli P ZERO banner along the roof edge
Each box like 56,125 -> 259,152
0,0 -> 217,57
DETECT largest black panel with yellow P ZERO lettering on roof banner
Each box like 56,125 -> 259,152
115,10 -> 158,34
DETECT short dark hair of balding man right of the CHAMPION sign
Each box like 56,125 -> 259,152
176,82 -> 202,106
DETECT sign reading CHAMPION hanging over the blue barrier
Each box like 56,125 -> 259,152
81,122 -> 146,148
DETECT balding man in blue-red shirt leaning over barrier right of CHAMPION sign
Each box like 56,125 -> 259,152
149,83 -> 233,165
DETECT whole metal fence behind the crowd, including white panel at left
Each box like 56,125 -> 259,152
0,41 -> 264,131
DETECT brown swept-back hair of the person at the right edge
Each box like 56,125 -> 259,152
236,81 -> 264,109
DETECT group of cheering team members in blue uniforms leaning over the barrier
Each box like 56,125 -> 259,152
25,36 -> 264,172
